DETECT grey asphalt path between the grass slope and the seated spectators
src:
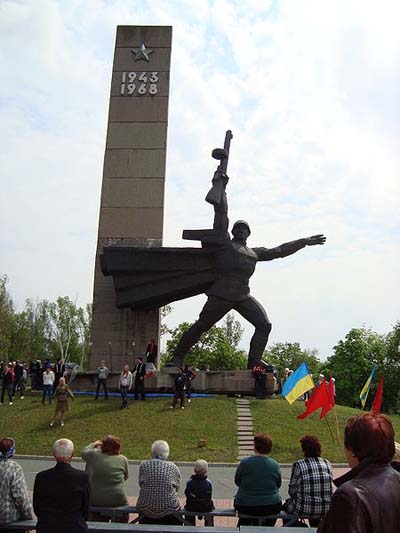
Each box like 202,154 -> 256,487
15,456 -> 347,499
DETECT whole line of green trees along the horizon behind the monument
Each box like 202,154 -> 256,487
0,276 -> 400,412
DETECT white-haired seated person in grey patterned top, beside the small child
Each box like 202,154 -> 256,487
136,440 -> 181,524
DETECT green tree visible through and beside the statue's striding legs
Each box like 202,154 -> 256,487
161,322 -> 247,370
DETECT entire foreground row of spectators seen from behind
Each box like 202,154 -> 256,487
0,412 -> 400,533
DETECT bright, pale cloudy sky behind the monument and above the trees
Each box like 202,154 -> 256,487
0,0 -> 400,359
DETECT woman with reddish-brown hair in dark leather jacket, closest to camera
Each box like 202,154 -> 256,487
318,412 -> 400,533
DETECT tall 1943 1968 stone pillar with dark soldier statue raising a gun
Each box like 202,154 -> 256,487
90,26 -> 325,392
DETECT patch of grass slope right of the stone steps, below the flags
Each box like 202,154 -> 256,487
251,398 -> 400,463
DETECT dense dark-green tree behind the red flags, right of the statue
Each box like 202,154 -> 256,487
321,328 -> 386,407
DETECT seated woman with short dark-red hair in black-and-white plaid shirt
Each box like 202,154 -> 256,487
284,435 -> 332,527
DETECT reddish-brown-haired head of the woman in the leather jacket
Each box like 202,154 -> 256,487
344,412 -> 395,468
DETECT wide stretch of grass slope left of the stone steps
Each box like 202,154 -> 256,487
0,393 -> 237,462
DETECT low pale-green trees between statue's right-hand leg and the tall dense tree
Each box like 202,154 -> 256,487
263,342 -> 321,376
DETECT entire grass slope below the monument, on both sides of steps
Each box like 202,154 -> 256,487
0,393 -> 400,463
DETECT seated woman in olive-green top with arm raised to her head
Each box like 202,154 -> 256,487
81,435 -> 129,522
